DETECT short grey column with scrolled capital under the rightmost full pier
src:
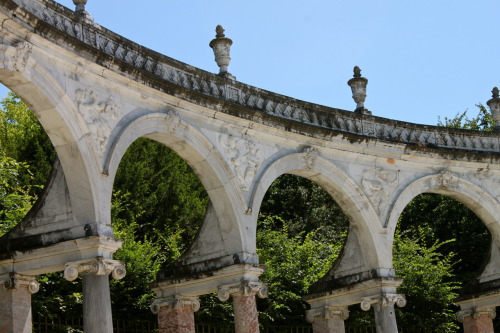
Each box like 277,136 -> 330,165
361,294 -> 406,333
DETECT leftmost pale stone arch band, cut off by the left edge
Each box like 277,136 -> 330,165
0,42 -> 104,238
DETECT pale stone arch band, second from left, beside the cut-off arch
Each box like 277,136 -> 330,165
103,110 -> 247,253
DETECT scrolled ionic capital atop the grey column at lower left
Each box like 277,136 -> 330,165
64,257 -> 127,281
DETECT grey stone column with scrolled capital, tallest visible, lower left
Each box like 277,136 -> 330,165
64,257 -> 126,333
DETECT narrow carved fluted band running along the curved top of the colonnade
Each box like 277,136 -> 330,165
8,0 -> 500,152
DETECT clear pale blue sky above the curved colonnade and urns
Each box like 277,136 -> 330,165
6,0 -> 500,124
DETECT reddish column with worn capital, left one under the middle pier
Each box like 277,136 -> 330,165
151,295 -> 200,333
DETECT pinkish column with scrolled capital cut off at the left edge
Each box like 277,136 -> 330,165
0,273 -> 40,333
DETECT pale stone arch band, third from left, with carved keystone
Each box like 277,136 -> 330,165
251,153 -> 390,268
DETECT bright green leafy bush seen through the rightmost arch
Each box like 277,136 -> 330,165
394,229 -> 460,333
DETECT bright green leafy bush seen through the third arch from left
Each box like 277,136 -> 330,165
257,216 -> 342,325
